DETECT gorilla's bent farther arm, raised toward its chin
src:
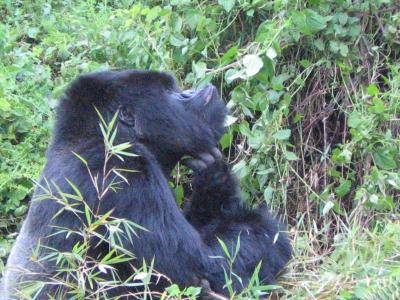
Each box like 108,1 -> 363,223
187,159 -> 292,291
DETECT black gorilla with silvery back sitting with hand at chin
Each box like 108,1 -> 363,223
2,71 -> 291,300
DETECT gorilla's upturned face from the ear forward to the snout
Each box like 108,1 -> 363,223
114,71 -> 227,169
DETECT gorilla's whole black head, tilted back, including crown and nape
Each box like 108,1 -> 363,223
54,71 -> 226,173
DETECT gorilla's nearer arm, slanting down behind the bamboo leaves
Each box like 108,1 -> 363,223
104,143 -> 225,291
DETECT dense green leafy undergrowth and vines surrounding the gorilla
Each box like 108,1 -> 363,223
0,0 -> 400,299
